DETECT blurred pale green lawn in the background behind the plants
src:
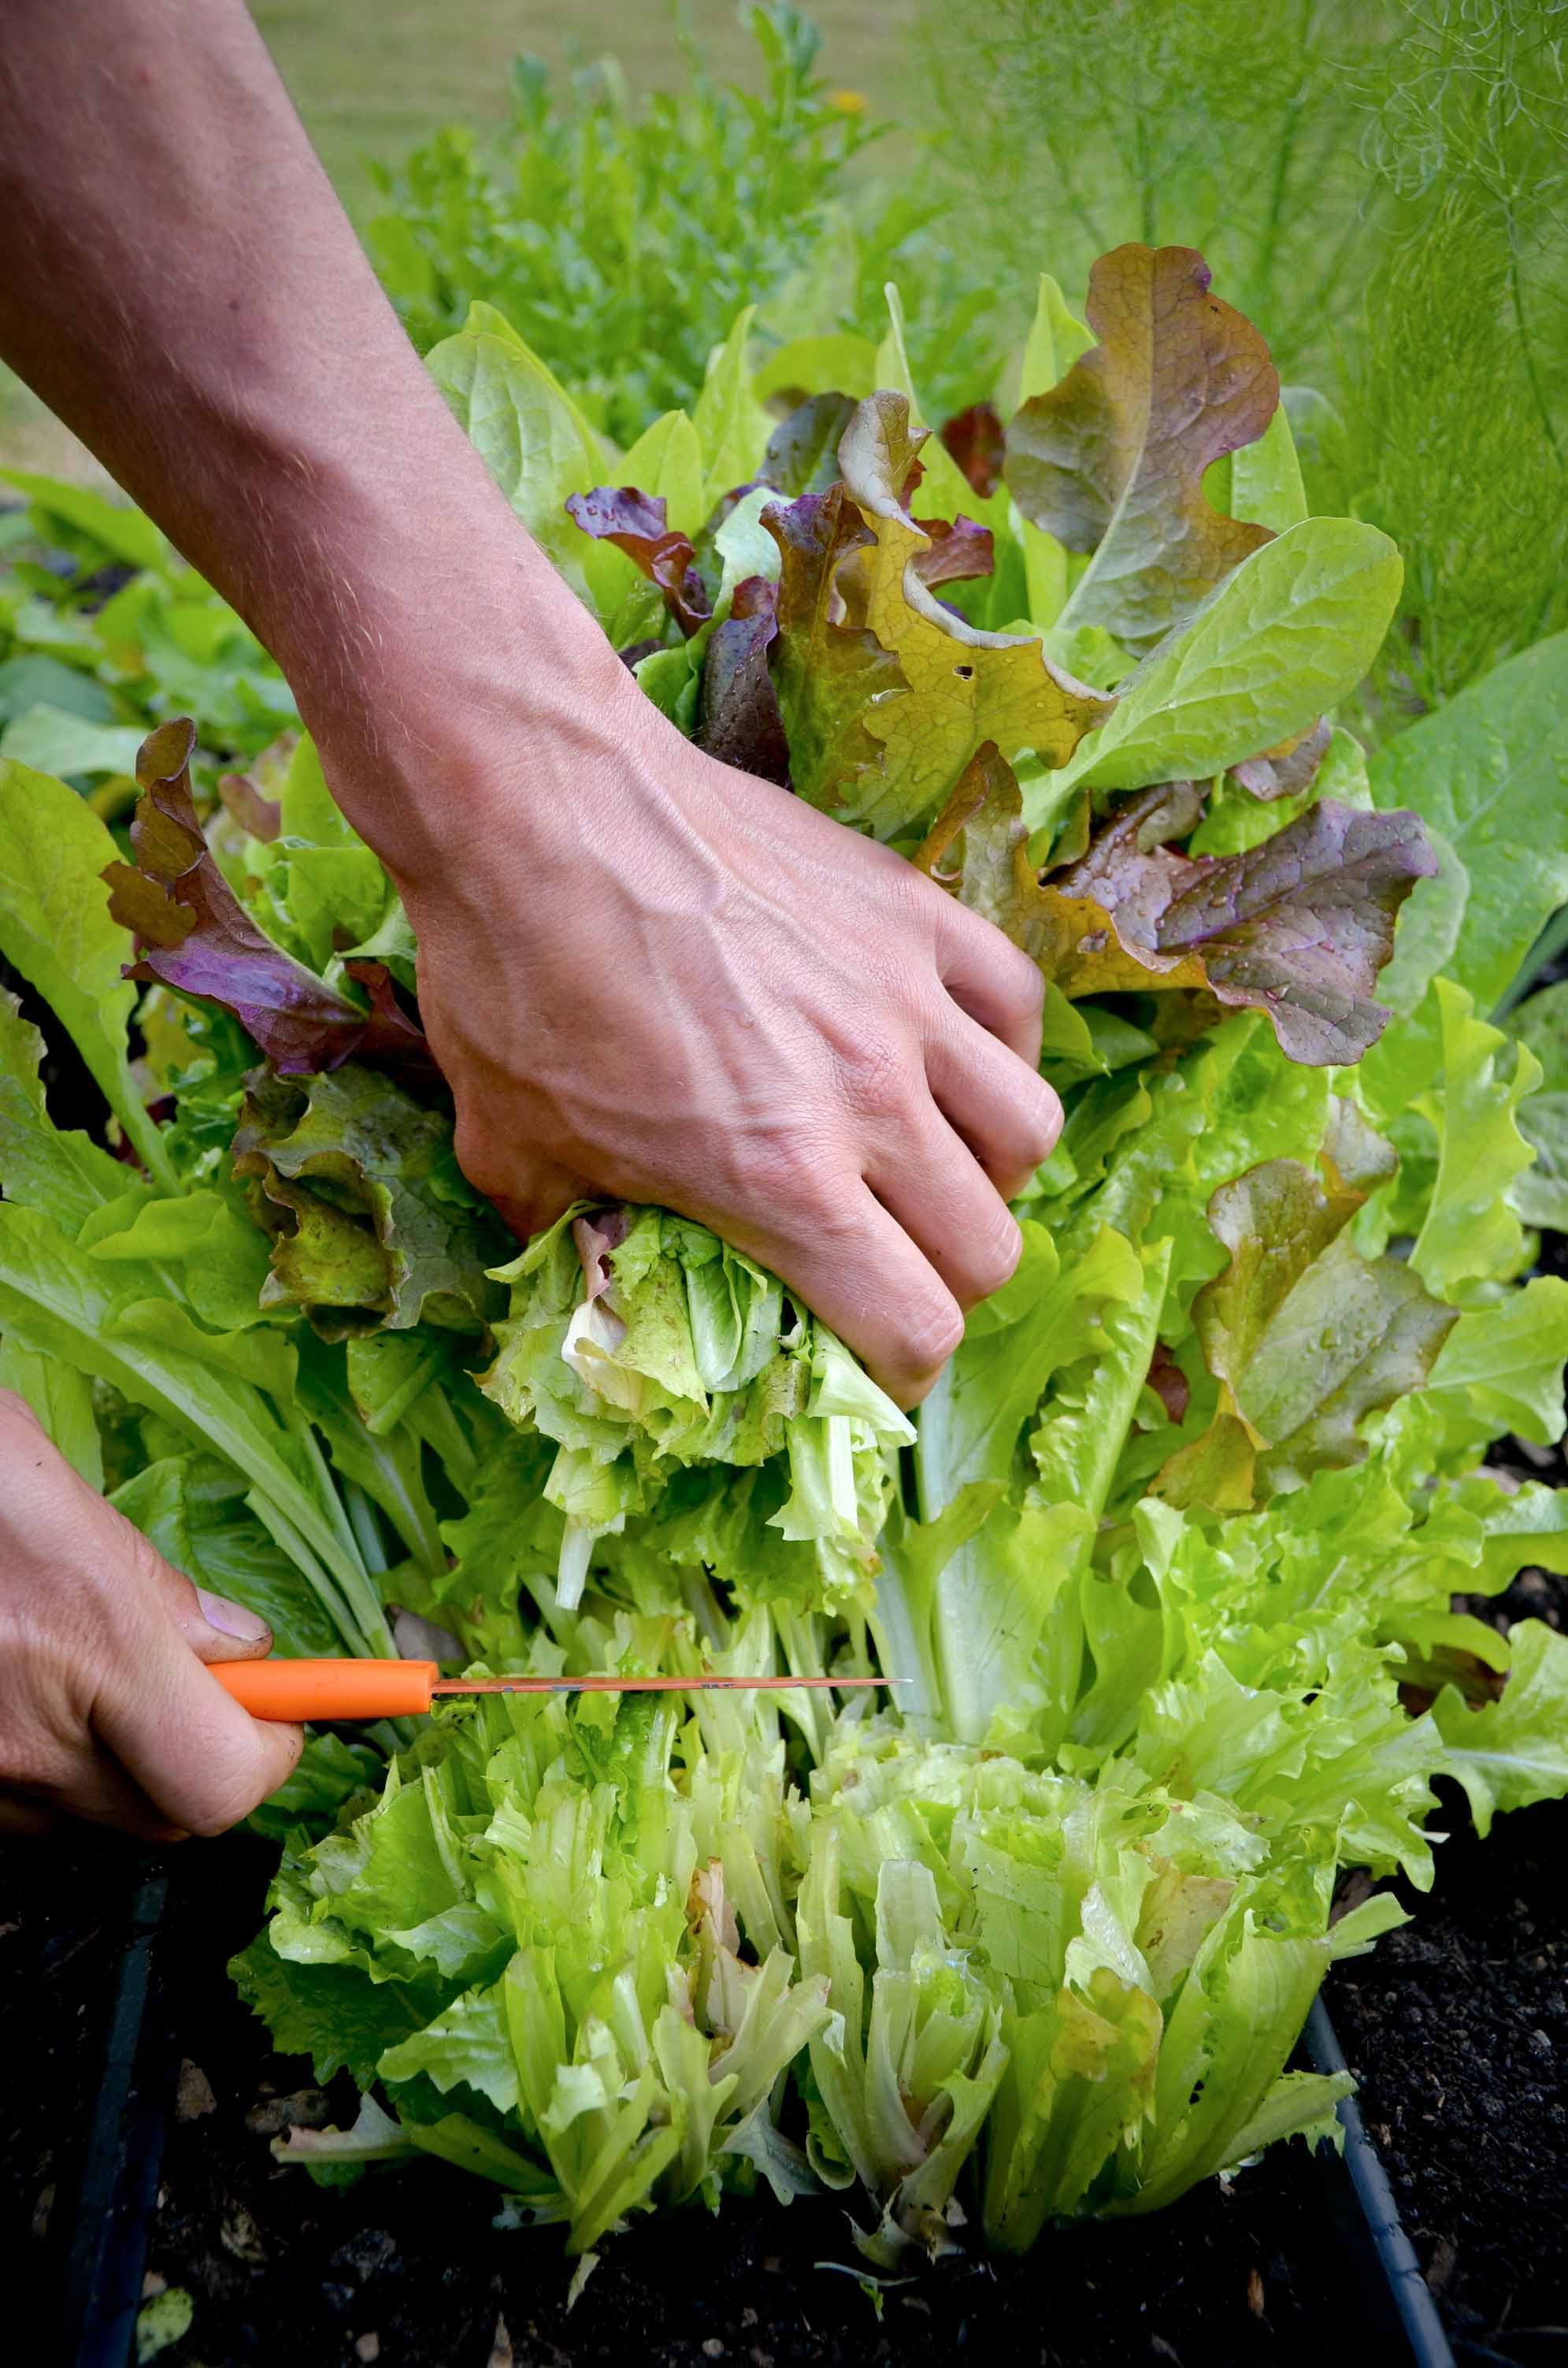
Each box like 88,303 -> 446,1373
0,0 -> 921,483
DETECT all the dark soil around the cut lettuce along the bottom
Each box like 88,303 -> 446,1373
0,1771 -> 1568,2368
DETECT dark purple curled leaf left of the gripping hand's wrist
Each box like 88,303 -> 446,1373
104,718 -> 436,1078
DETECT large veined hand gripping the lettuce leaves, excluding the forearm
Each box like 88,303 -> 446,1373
374,666 -> 1061,1405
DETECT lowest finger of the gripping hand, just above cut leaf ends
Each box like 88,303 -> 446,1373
727,1177 -> 964,1407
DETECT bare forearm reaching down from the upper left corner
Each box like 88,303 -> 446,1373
0,0 -> 613,869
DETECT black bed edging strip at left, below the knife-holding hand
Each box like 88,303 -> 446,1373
59,1852 -> 178,2368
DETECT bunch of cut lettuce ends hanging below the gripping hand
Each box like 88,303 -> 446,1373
481,1208 -> 914,1608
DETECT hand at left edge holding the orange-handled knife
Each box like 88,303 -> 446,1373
0,1390 -> 303,1843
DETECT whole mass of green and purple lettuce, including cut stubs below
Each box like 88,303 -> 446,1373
0,247 -> 1568,2266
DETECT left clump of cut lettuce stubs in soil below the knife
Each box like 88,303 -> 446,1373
232,1657 -> 829,2252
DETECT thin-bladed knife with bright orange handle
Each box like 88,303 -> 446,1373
206,1660 -> 900,1724
